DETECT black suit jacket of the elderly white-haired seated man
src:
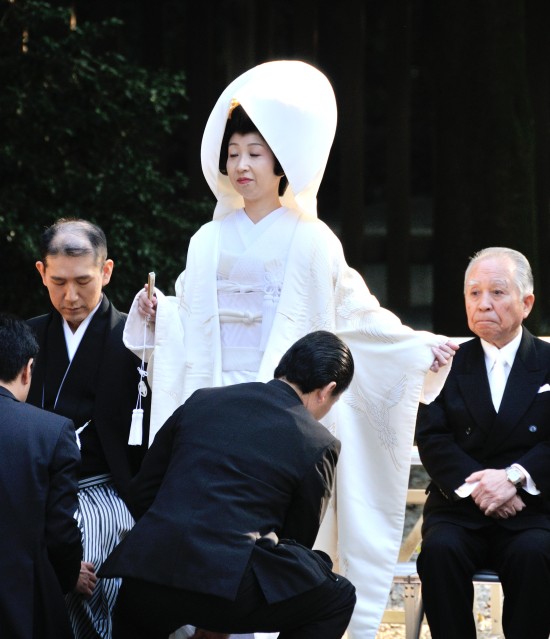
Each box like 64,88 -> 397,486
417,328 -> 550,529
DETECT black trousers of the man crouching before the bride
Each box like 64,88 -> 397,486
113,566 -> 356,639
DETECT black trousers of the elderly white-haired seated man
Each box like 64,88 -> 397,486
417,522 -> 550,639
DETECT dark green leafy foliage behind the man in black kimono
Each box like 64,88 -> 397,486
0,0 -> 211,317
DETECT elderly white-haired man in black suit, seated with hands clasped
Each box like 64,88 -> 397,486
417,247 -> 550,639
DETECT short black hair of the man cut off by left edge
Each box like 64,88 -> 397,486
0,313 -> 39,383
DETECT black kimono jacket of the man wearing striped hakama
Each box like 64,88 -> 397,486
27,295 -> 149,510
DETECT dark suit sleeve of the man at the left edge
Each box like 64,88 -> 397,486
45,420 -> 82,593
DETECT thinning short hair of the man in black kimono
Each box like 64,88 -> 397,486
40,218 -> 107,264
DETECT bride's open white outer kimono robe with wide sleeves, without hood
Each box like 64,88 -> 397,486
124,210 -> 449,639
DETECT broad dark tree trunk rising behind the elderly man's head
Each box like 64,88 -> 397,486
432,0 -> 537,335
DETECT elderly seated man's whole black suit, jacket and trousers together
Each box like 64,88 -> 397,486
417,328 -> 550,639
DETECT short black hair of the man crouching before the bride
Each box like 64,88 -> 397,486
274,331 -> 354,395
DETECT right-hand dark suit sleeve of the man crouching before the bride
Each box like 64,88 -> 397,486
280,440 -> 340,548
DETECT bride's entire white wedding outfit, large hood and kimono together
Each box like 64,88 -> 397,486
124,60 -> 450,639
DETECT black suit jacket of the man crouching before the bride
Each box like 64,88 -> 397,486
100,380 -> 340,603
